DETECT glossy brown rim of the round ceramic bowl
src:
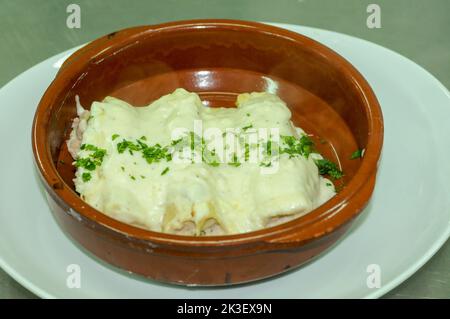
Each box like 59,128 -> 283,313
31,19 -> 384,247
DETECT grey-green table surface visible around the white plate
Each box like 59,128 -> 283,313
0,0 -> 450,298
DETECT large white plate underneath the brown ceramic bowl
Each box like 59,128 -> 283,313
0,25 -> 450,298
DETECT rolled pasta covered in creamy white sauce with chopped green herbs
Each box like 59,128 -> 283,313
67,89 -> 342,236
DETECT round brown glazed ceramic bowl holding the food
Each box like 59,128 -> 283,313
32,20 -> 383,285
